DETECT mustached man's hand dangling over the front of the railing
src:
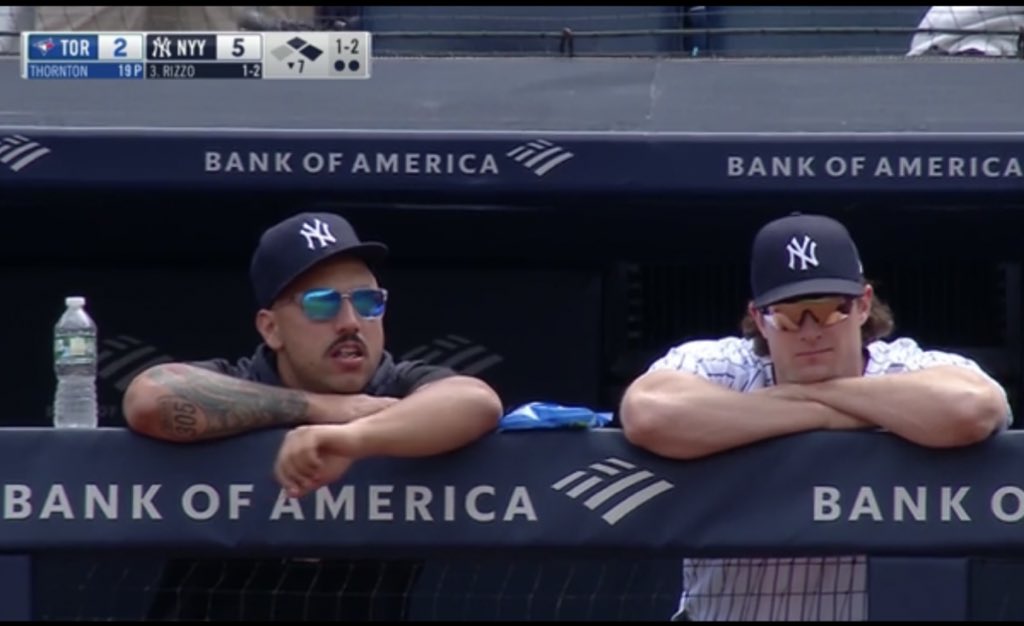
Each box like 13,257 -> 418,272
273,424 -> 357,498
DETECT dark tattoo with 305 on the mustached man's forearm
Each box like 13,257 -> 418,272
145,366 -> 309,440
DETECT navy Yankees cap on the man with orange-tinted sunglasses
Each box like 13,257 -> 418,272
751,213 -> 864,308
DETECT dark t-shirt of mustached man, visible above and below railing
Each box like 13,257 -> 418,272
147,344 -> 456,621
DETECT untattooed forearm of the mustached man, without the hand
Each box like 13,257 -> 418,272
330,376 -> 502,457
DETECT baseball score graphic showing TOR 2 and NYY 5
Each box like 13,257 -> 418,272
22,32 -> 372,80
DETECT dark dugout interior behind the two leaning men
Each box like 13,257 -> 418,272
0,190 -> 1024,425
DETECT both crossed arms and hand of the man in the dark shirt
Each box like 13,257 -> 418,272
123,363 -> 503,497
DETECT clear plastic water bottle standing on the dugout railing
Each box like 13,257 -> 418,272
53,296 -> 99,428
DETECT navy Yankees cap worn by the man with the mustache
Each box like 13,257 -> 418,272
249,213 -> 388,308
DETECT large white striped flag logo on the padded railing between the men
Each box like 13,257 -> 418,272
551,457 -> 675,526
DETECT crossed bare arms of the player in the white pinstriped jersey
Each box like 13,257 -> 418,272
620,366 -> 1010,459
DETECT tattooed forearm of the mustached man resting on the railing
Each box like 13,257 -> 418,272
124,364 -> 310,442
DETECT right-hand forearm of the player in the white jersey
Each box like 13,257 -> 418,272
797,366 -> 1009,448
